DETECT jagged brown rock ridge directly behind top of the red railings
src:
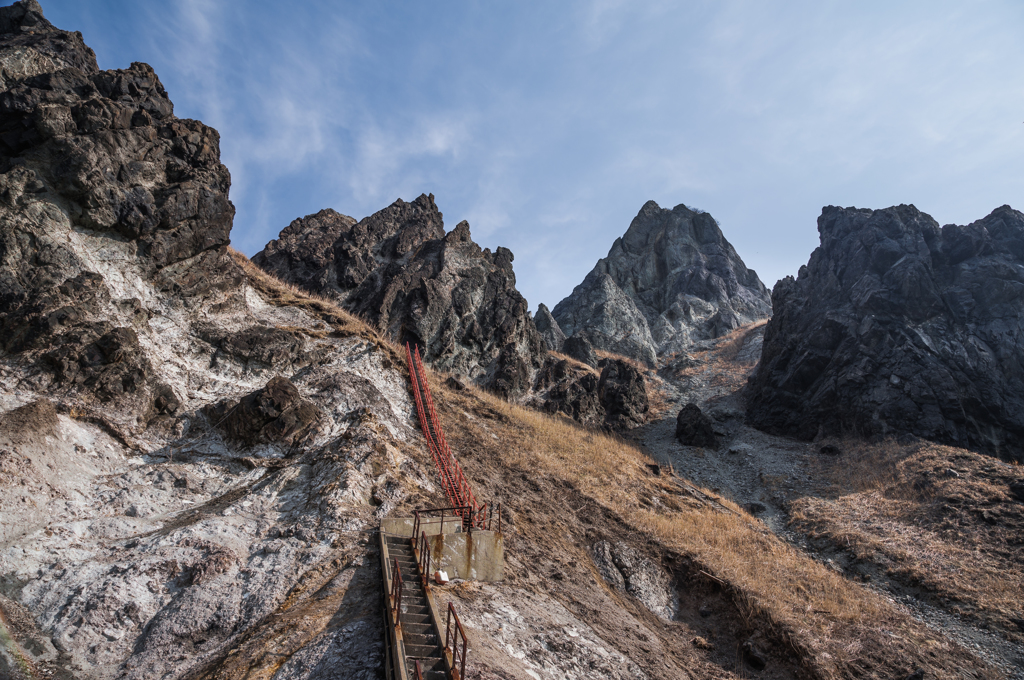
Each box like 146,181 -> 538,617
253,196 -> 544,396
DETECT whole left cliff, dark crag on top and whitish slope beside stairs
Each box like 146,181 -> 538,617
0,0 -> 417,679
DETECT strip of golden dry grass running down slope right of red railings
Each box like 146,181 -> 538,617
423,378 -> 983,678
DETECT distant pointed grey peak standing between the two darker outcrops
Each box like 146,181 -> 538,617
551,201 -> 771,366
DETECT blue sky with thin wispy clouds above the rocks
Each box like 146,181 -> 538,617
34,0 -> 1024,309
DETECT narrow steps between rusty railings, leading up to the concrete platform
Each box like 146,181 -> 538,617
386,536 -> 449,680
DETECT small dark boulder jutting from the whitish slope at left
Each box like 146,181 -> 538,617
207,376 -> 321,444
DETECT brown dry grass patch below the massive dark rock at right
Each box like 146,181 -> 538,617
792,441 -> 1024,641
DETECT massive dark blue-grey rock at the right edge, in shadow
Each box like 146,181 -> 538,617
748,206 -> 1024,460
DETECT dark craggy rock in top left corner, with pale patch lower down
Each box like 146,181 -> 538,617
0,0 -> 234,422
